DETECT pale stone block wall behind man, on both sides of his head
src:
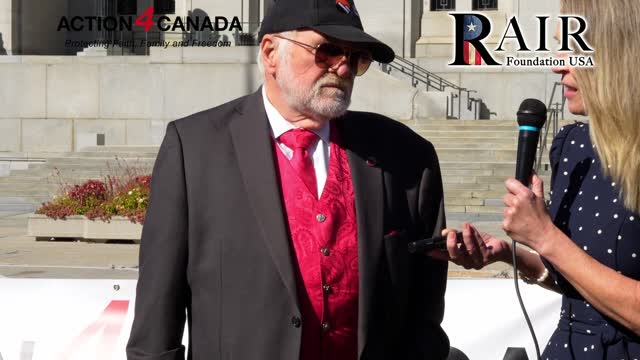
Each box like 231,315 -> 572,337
0,47 -> 584,153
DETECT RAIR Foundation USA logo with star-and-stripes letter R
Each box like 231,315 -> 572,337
449,13 -> 594,67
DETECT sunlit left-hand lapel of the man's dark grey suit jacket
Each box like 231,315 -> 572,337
230,89 -> 298,306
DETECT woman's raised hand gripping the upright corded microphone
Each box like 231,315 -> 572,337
502,174 -> 556,256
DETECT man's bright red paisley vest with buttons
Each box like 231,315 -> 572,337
274,127 -> 358,360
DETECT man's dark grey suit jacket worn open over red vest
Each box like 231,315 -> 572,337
127,91 -> 449,360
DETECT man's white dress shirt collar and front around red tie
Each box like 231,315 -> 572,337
262,86 -> 330,199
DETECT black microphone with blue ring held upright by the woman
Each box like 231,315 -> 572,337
516,99 -> 547,187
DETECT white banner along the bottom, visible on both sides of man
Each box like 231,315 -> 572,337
0,278 -> 560,360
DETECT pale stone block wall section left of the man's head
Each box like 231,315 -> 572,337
0,48 -> 261,152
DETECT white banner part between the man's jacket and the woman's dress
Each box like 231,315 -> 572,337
442,279 -> 561,360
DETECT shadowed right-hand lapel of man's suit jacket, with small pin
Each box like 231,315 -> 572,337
336,118 -> 384,358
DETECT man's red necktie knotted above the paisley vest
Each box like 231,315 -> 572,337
280,129 -> 318,199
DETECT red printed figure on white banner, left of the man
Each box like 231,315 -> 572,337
59,300 -> 129,360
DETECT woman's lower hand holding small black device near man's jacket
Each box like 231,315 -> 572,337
427,223 -> 511,270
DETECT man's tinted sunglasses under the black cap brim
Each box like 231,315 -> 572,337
274,35 -> 373,76
